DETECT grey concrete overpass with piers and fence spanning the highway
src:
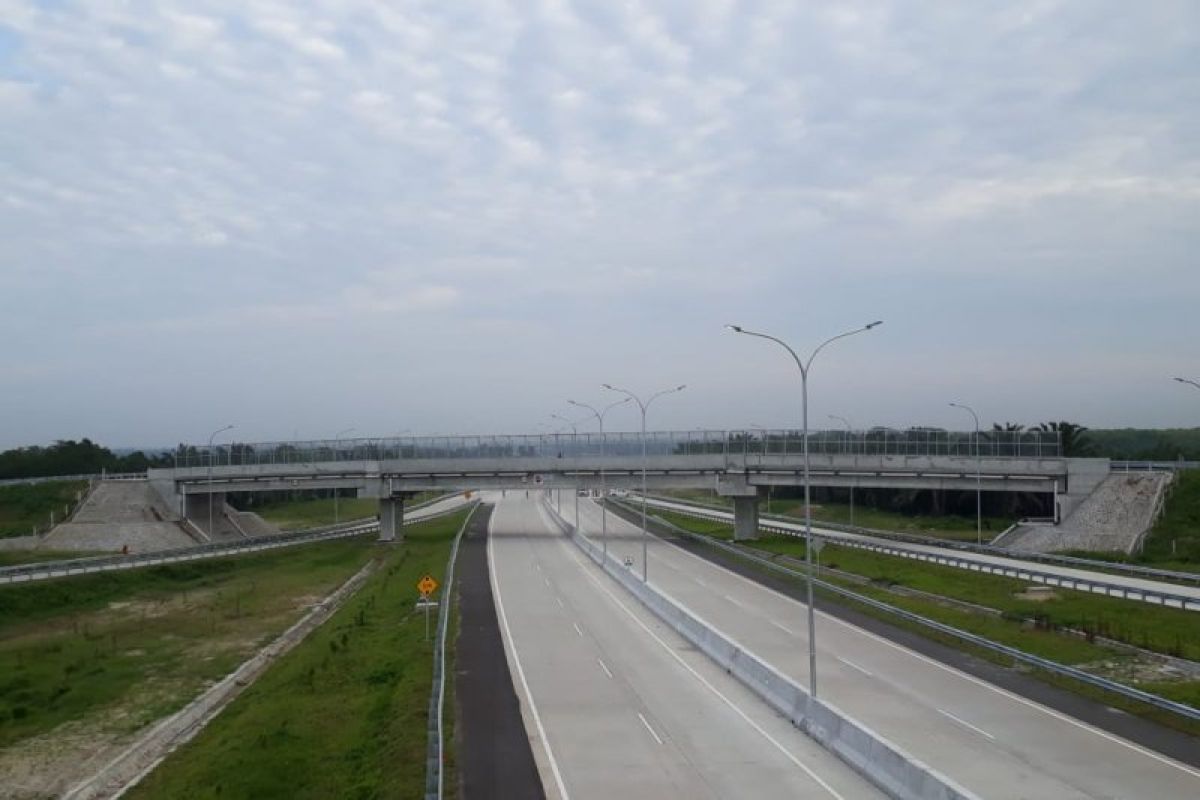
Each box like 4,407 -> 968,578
149,428 -> 1109,540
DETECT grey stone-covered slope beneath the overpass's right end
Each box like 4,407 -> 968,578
1003,473 -> 1172,553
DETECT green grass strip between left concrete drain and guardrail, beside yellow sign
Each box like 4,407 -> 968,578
127,515 -> 464,799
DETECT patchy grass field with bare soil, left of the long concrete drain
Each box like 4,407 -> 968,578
0,540 -> 373,747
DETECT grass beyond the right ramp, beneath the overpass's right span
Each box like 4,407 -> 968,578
665,489 -> 1014,542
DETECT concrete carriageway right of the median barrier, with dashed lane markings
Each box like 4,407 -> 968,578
562,493 -> 1200,800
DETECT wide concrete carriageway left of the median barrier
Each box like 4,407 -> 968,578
488,492 -> 883,800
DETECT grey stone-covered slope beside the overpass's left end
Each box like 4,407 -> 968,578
41,481 -> 197,553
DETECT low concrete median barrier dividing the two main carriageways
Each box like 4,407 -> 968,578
547,504 -> 978,800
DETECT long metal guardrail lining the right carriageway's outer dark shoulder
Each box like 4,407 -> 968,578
618,503 -> 1200,721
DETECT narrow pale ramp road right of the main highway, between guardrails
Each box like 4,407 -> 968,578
630,497 -> 1200,609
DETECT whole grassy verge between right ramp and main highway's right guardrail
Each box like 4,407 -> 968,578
658,512 -> 1200,708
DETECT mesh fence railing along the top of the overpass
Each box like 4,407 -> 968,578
175,428 -> 1061,468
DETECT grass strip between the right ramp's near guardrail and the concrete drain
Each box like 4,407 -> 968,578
659,513 -> 1200,663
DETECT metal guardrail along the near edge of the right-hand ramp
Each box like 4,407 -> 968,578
657,509 -> 1200,610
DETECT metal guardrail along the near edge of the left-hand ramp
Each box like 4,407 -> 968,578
0,501 -> 461,585
